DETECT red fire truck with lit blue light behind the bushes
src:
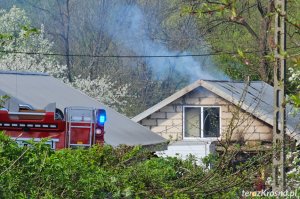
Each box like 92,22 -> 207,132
0,103 -> 106,150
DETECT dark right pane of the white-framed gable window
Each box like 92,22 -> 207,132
203,107 -> 220,137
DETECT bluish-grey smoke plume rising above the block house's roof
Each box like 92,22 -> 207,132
104,5 -> 227,81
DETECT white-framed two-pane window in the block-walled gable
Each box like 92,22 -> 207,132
183,106 -> 220,138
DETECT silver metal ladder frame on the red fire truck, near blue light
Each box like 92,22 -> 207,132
65,107 -> 95,148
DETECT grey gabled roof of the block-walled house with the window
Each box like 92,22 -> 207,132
132,80 -> 300,140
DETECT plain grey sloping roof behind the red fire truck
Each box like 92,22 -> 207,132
0,71 -> 167,148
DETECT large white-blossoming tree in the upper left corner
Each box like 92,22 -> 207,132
0,7 -> 65,79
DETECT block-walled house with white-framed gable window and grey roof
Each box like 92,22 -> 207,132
132,80 -> 300,157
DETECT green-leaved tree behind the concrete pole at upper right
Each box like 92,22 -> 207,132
185,0 -> 300,83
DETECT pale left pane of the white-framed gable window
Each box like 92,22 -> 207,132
184,107 -> 201,137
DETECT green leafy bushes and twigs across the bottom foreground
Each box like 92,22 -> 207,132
0,132 -> 298,198
